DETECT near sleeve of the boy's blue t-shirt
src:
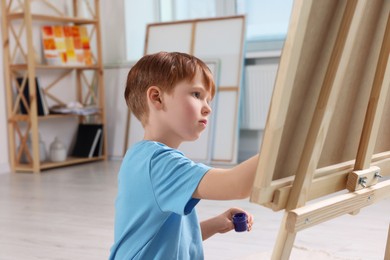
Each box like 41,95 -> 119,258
149,149 -> 210,215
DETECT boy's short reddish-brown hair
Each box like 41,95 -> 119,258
125,52 -> 215,125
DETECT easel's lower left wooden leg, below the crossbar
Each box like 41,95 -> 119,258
272,211 -> 296,260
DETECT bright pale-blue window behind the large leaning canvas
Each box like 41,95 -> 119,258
124,0 -> 293,61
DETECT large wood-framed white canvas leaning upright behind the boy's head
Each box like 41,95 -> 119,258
133,16 -> 245,164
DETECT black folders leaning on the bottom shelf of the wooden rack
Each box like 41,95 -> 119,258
72,124 -> 103,158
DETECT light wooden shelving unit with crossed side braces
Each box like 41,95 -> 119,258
1,0 -> 107,173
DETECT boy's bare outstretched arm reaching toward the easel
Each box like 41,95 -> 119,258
193,154 -> 259,200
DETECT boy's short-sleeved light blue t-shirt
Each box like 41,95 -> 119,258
110,141 -> 210,260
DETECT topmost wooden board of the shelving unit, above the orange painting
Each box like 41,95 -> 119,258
8,12 -> 98,25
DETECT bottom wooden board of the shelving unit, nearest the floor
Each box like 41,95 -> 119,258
15,156 -> 105,172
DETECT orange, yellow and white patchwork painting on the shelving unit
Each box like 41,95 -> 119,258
41,25 -> 93,65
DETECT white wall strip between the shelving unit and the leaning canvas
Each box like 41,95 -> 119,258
100,0 -> 129,159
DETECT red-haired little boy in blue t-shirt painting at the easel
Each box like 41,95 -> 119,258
110,52 -> 258,260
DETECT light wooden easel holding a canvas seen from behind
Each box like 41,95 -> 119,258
251,0 -> 390,260
